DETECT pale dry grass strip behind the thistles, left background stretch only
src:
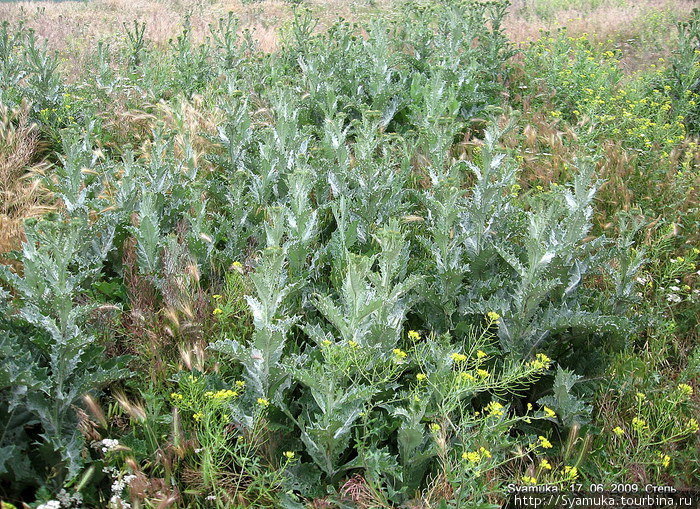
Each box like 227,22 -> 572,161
0,0 -> 391,64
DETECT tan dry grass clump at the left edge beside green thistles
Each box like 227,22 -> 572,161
0,104 -> 47,254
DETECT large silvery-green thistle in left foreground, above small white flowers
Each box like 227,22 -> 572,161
2,219 -> 128,484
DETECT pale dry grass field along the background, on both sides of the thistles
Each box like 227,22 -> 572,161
0,0 -> 697,76
